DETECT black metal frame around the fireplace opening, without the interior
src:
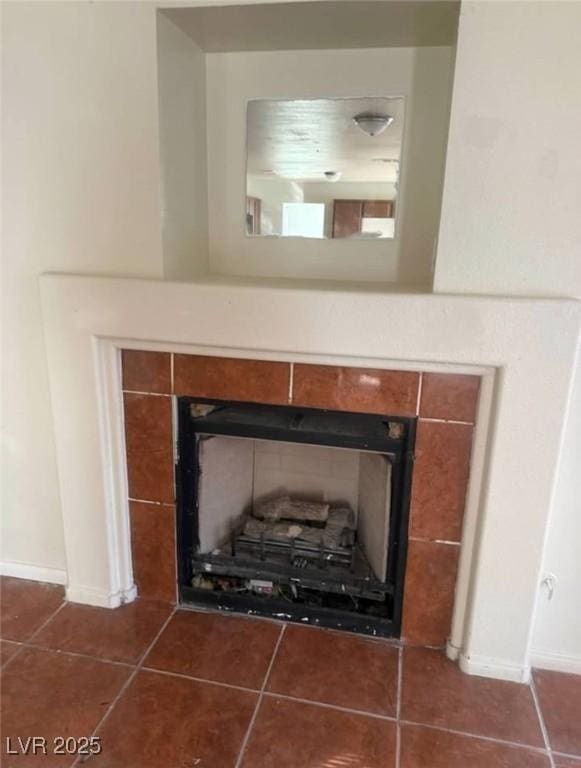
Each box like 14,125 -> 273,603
176,397 -> 416,638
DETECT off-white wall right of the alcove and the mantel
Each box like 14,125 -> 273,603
434,2 -> 581,670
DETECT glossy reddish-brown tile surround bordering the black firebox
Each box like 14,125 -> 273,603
122,350 -> 480,646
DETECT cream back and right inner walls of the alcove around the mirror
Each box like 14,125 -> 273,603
206,47 -> 453,284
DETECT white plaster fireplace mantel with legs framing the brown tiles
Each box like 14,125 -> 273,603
41,275 -> 581,680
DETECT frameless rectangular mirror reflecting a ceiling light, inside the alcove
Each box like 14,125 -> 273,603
245,97 -> 404,240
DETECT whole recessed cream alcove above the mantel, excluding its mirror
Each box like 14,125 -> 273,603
157,2 -> 459,291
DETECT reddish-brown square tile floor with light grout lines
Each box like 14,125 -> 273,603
0,578 -> 581,768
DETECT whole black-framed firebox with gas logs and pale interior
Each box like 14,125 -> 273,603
177,397 -> 415,637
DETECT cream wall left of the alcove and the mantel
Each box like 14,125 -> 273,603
0,2 -> 162,578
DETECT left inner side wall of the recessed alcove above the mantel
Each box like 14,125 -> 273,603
157,13 -> 208,280
